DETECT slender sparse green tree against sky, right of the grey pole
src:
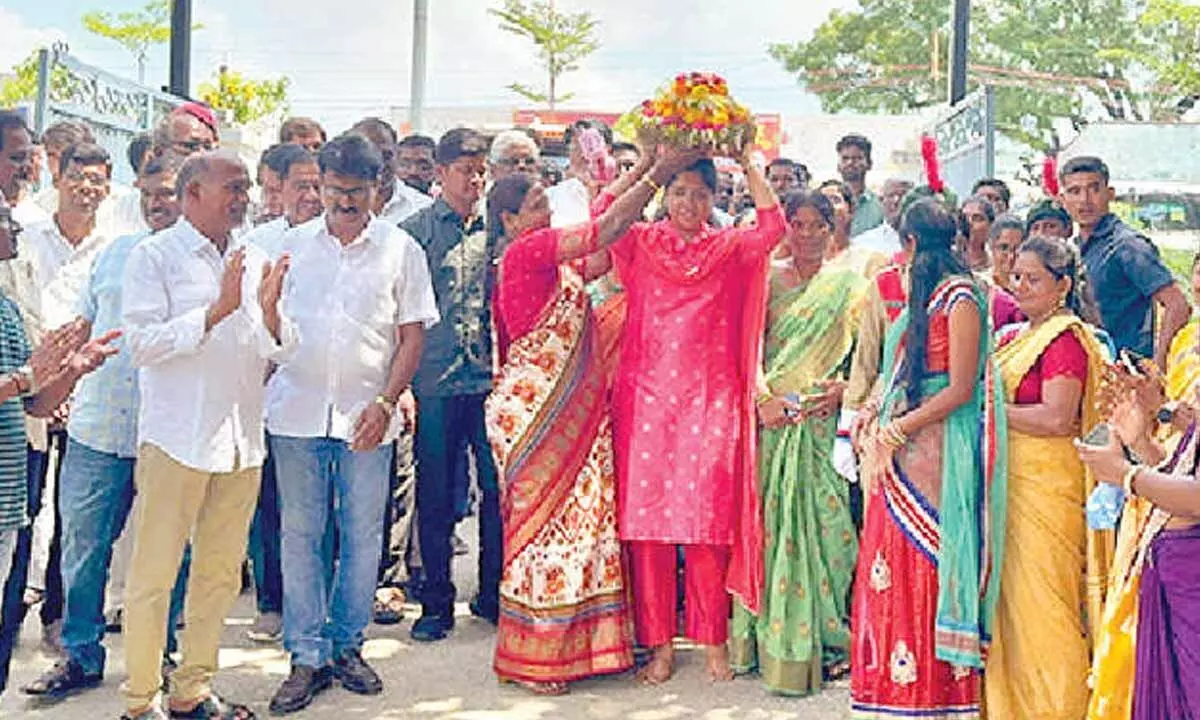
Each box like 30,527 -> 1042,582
487,0 -> 600,109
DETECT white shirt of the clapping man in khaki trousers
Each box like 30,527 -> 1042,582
122,218 -> 278,473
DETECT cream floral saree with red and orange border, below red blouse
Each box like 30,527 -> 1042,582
487,265 -> 634,683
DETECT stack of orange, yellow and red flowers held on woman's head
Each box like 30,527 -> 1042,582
630,72 -> 755,156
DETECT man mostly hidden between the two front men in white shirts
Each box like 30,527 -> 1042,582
242,145 -> 324,642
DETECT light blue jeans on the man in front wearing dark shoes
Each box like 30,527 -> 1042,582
271,436 -> 395,667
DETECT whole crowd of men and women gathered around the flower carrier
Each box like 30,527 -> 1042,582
0,103 -> 1200,720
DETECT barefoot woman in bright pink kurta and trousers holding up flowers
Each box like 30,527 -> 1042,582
612,147 -> 786,684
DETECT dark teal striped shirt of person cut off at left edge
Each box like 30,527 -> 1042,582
0,295 -> 29,532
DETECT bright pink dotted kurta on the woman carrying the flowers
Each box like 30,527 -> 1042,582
613,208 -> 786,545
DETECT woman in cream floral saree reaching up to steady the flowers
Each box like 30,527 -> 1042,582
487,142 -> 698,695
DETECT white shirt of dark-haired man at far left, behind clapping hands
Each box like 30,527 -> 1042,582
22,217 -> 112,330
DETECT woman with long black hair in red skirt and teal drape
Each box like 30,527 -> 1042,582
851,199 -> 1007,719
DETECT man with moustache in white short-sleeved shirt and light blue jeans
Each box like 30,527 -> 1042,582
266,134 -> 438,714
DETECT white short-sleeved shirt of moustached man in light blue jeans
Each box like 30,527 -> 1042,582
266,217 -> 439,442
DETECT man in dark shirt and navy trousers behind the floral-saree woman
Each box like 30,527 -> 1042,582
402,128 -> 503,642
